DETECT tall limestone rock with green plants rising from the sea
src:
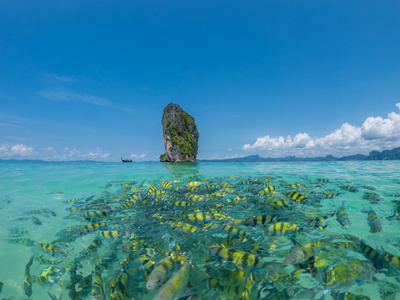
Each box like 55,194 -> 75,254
160,103 -> 199,162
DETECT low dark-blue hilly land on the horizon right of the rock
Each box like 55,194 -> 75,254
198,147 -> 400,162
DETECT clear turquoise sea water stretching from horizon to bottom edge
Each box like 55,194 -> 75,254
0,161 -> 400,299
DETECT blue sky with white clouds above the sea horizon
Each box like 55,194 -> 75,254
0,0 -> 400,161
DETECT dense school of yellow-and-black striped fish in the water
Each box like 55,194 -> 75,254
4,176 -> 400,300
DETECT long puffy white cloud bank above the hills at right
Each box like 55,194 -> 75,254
242,103 -> 400,155
